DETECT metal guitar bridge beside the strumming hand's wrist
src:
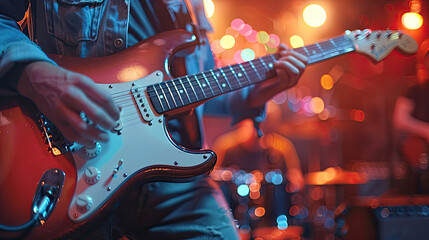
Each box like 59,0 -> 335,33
39,114 -> 71,156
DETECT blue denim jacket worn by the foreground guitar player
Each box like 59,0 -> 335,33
0,0 -> 264,144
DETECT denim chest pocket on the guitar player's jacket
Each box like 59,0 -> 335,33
44,0 -> 104,45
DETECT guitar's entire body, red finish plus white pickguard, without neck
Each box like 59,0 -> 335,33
0,31 -> 216,239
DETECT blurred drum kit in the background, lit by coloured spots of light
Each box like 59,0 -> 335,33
211,167 -> 368,240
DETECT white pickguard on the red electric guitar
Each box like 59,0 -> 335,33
68,72 -> 212,222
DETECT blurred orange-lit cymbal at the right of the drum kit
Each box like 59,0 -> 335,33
305,167 -> 368,185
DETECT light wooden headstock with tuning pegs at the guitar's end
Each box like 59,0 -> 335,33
346,29 -> 419,62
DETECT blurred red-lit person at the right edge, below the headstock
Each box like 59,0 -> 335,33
393,40 -> 429,194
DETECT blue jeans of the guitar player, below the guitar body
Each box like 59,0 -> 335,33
86,177 -> 239,240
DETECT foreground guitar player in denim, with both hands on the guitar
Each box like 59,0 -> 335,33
0,0 -> 307,239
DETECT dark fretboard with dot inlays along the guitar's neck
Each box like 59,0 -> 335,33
147,36 -> 356,113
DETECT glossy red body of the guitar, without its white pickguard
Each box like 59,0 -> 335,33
0,31 -> 215,239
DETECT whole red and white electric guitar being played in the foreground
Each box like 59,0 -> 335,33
0,30 -> 418,239
